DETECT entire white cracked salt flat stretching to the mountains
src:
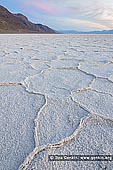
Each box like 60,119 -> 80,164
0,34 -> 113,170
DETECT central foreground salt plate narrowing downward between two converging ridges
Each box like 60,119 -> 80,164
35,97 -> 89,146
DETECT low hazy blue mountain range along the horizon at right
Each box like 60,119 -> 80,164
59,30 -> 113,34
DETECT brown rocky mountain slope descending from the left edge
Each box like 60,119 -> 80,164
0,5 -> 56,33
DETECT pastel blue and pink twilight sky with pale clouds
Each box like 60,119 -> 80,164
0,0 -> 113,31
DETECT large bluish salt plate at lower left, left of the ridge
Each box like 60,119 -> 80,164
0,86 -> 44,170
